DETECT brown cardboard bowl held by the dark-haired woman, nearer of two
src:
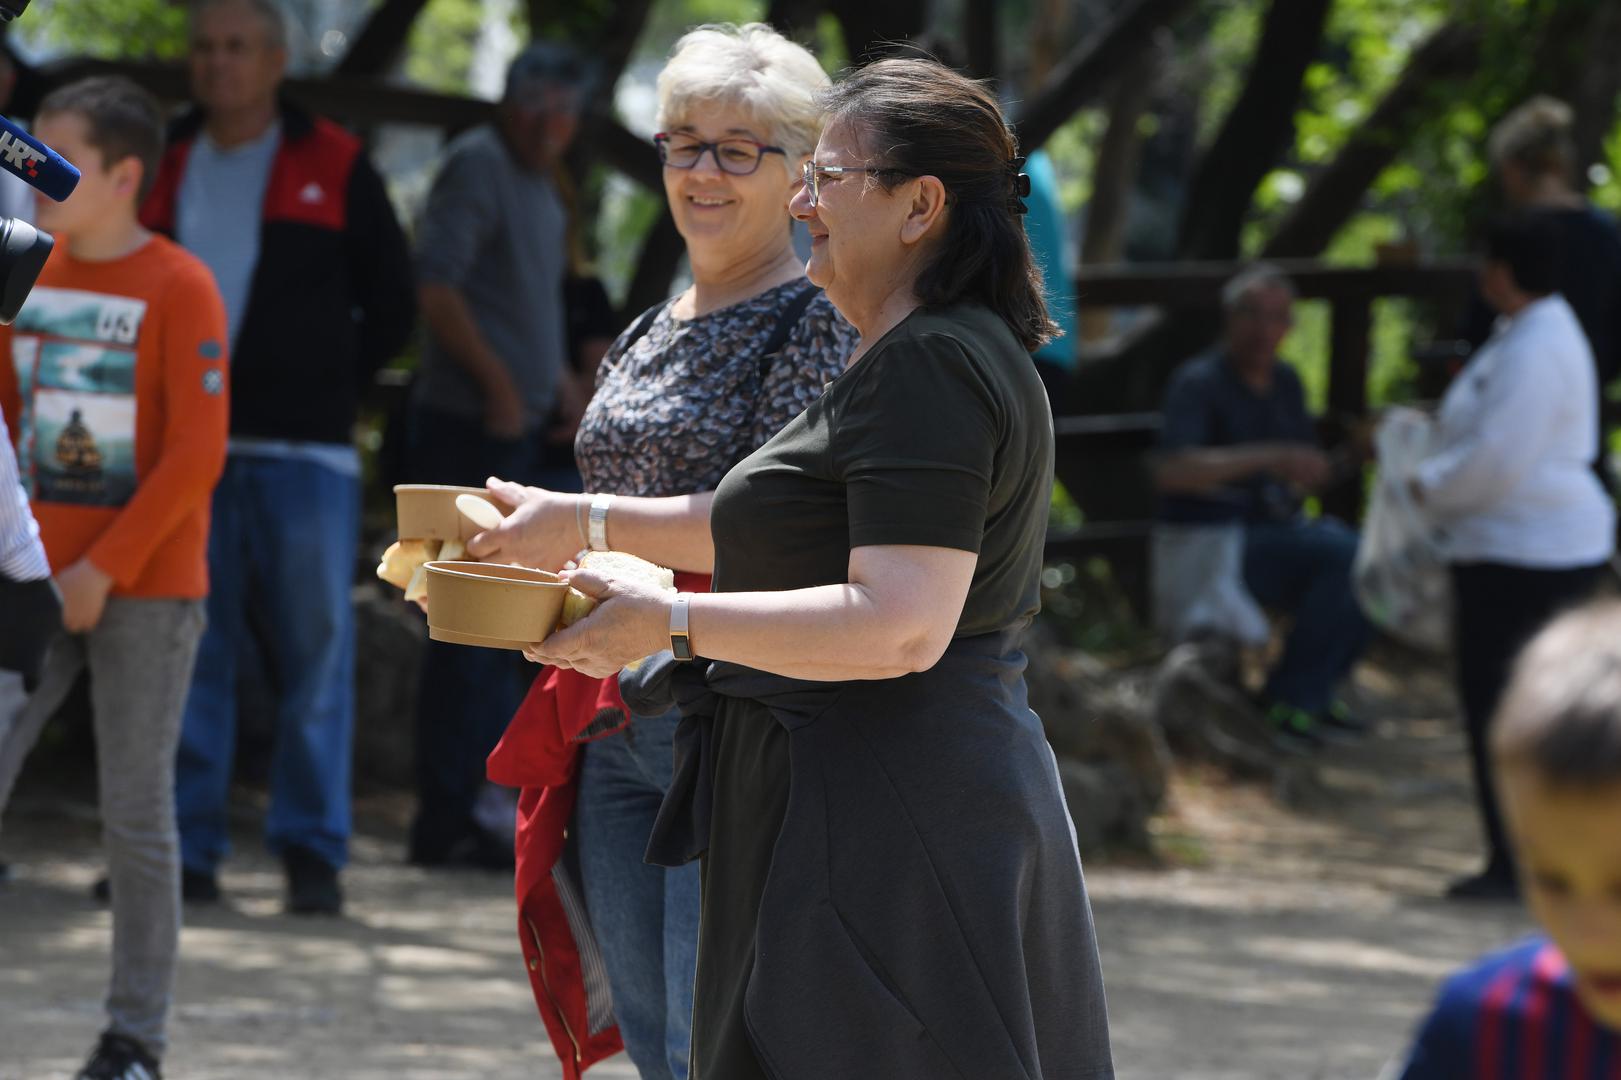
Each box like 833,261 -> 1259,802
428,563 -> 569,649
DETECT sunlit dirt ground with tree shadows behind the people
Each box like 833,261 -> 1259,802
0,651 -> 1527,1080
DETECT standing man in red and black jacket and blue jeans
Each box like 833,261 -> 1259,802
141,0 -> 415,913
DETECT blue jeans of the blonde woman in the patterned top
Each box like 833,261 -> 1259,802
574,712 -> 699,1080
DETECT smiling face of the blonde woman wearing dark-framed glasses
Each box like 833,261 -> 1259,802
665,102 -> 802,272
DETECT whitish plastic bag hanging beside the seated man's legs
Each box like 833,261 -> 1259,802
1153,522 -> 1269,645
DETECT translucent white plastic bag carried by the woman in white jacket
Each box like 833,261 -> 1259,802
1352,407 -> 1452,652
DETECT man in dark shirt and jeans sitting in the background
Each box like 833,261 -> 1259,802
1154,264 -> 1368,748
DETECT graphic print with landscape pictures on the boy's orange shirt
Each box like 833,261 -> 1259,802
11,287 -> 146,506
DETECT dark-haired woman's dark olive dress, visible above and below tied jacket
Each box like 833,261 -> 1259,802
692,305 -> 1052,1080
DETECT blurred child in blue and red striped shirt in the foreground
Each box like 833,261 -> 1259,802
1402,602 -> 1621,1080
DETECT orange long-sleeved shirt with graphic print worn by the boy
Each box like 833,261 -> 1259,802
0,237 -> 230,598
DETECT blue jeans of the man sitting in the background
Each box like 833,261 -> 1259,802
1243,519 -> 1368,712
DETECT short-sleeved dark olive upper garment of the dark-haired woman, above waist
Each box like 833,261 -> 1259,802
716,296 -> 1052,632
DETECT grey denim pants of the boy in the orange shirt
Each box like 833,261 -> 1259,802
0,597 -> 204,1057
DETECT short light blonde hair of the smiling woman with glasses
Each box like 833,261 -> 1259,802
658,23 -> 830,172
